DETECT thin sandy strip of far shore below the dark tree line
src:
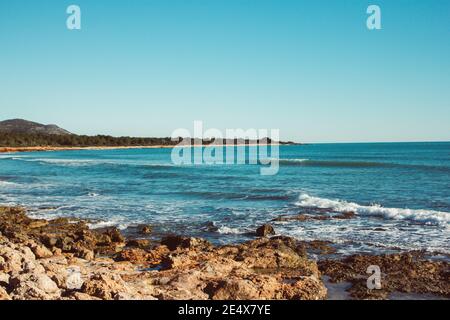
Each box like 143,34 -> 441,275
0,143 -> 292,153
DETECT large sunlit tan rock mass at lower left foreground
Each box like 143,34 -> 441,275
0,208 -> 327,300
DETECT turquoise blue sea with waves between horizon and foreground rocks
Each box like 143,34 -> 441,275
0,143 -> 450,254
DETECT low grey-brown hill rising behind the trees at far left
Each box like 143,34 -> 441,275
0,119 -> 71,135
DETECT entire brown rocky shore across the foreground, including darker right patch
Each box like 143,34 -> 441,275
0,207 -> 450,300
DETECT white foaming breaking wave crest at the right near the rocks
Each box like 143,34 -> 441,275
296,194 -> 450,226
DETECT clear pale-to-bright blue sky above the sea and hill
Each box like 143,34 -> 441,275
0,0 -> 450,142
